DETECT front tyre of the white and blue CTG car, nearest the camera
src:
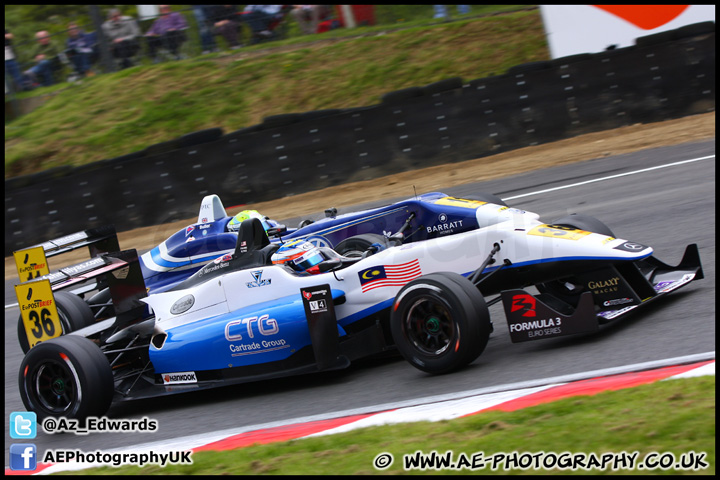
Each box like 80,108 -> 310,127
390,272 -> 492,374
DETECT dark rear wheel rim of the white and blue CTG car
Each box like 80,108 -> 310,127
33,361 -> 79,413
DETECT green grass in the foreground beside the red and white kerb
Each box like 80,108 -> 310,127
69,376 -> 715,475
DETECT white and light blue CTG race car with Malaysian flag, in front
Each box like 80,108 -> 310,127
18,195 -> 703,418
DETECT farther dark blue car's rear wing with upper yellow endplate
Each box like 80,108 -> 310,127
13,225 -> 120,282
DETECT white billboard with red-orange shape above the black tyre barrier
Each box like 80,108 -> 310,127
540,5 -> 715,58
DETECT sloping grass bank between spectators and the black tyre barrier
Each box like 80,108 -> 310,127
5,10 -> 549,178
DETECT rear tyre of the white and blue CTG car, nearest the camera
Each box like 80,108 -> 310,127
18,335 -> 114,419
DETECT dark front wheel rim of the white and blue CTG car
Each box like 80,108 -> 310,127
404,297 -> 455,355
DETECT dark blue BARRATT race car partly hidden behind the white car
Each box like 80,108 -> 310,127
8,192 -> 509,352
